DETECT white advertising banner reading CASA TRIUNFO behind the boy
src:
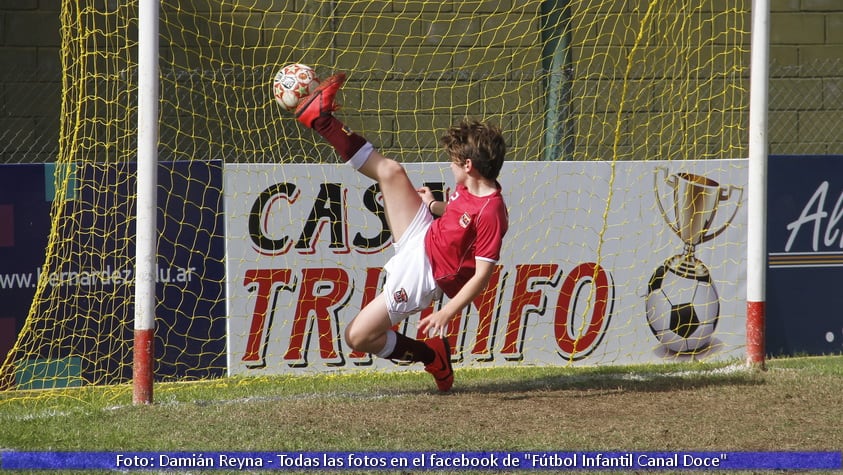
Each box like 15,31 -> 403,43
224,160 -> 747,374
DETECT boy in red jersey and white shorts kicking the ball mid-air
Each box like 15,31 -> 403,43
296,73 -> 509,391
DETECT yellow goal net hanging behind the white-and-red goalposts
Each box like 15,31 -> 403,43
0,0 -> 750,402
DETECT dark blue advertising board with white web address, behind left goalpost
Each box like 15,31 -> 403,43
0,161 -> 225,389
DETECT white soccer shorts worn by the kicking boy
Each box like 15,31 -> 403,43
383,206 -> 442,325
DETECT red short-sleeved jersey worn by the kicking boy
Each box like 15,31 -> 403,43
424,185 -> 509,297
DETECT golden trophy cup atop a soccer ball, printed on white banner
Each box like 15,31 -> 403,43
646,167 -> 743,353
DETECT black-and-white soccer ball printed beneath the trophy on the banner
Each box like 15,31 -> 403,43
646,264 -> 720,353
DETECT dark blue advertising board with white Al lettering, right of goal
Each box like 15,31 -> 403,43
766,156 -> 843,356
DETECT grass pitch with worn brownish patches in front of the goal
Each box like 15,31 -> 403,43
0,356 -> 843,473
